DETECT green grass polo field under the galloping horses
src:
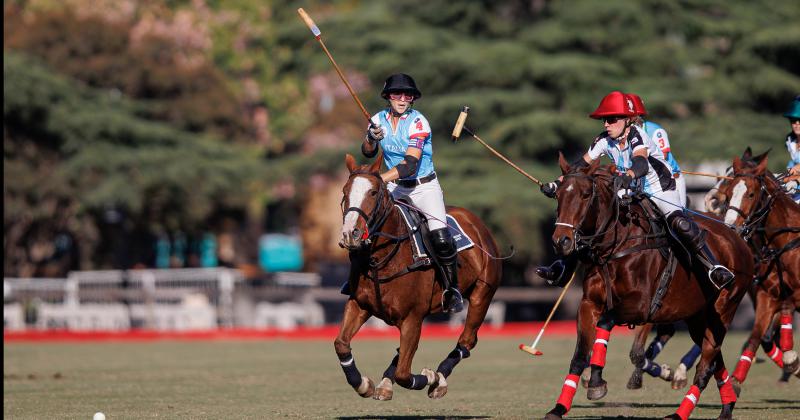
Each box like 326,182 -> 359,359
3,331 -> 800,420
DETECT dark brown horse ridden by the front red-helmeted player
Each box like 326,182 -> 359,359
545,155 -> 753,419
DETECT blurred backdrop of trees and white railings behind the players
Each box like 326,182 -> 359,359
3,0 -> 800,329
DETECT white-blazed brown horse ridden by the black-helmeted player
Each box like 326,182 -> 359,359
334,154 -> 501,400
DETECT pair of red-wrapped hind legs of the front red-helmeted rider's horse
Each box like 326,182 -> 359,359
665,312 -> 736,420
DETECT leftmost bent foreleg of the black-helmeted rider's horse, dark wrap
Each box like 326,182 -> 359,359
333,299 -> 375,398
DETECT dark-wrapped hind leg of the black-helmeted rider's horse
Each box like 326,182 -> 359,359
428,284 -> 493,398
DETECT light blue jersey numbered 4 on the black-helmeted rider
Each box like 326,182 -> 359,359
372,108 -> 434,179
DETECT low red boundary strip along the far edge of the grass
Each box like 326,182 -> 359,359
3,321 -> 629,343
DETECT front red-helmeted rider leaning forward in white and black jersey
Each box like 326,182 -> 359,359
536,91 -> 734,289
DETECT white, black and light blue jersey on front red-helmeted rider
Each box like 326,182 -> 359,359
588,125 -> 675,194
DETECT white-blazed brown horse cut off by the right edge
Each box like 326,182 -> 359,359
719,156 -> 800,394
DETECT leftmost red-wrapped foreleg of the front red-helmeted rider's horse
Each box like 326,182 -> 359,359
544,299 -> 600,420
